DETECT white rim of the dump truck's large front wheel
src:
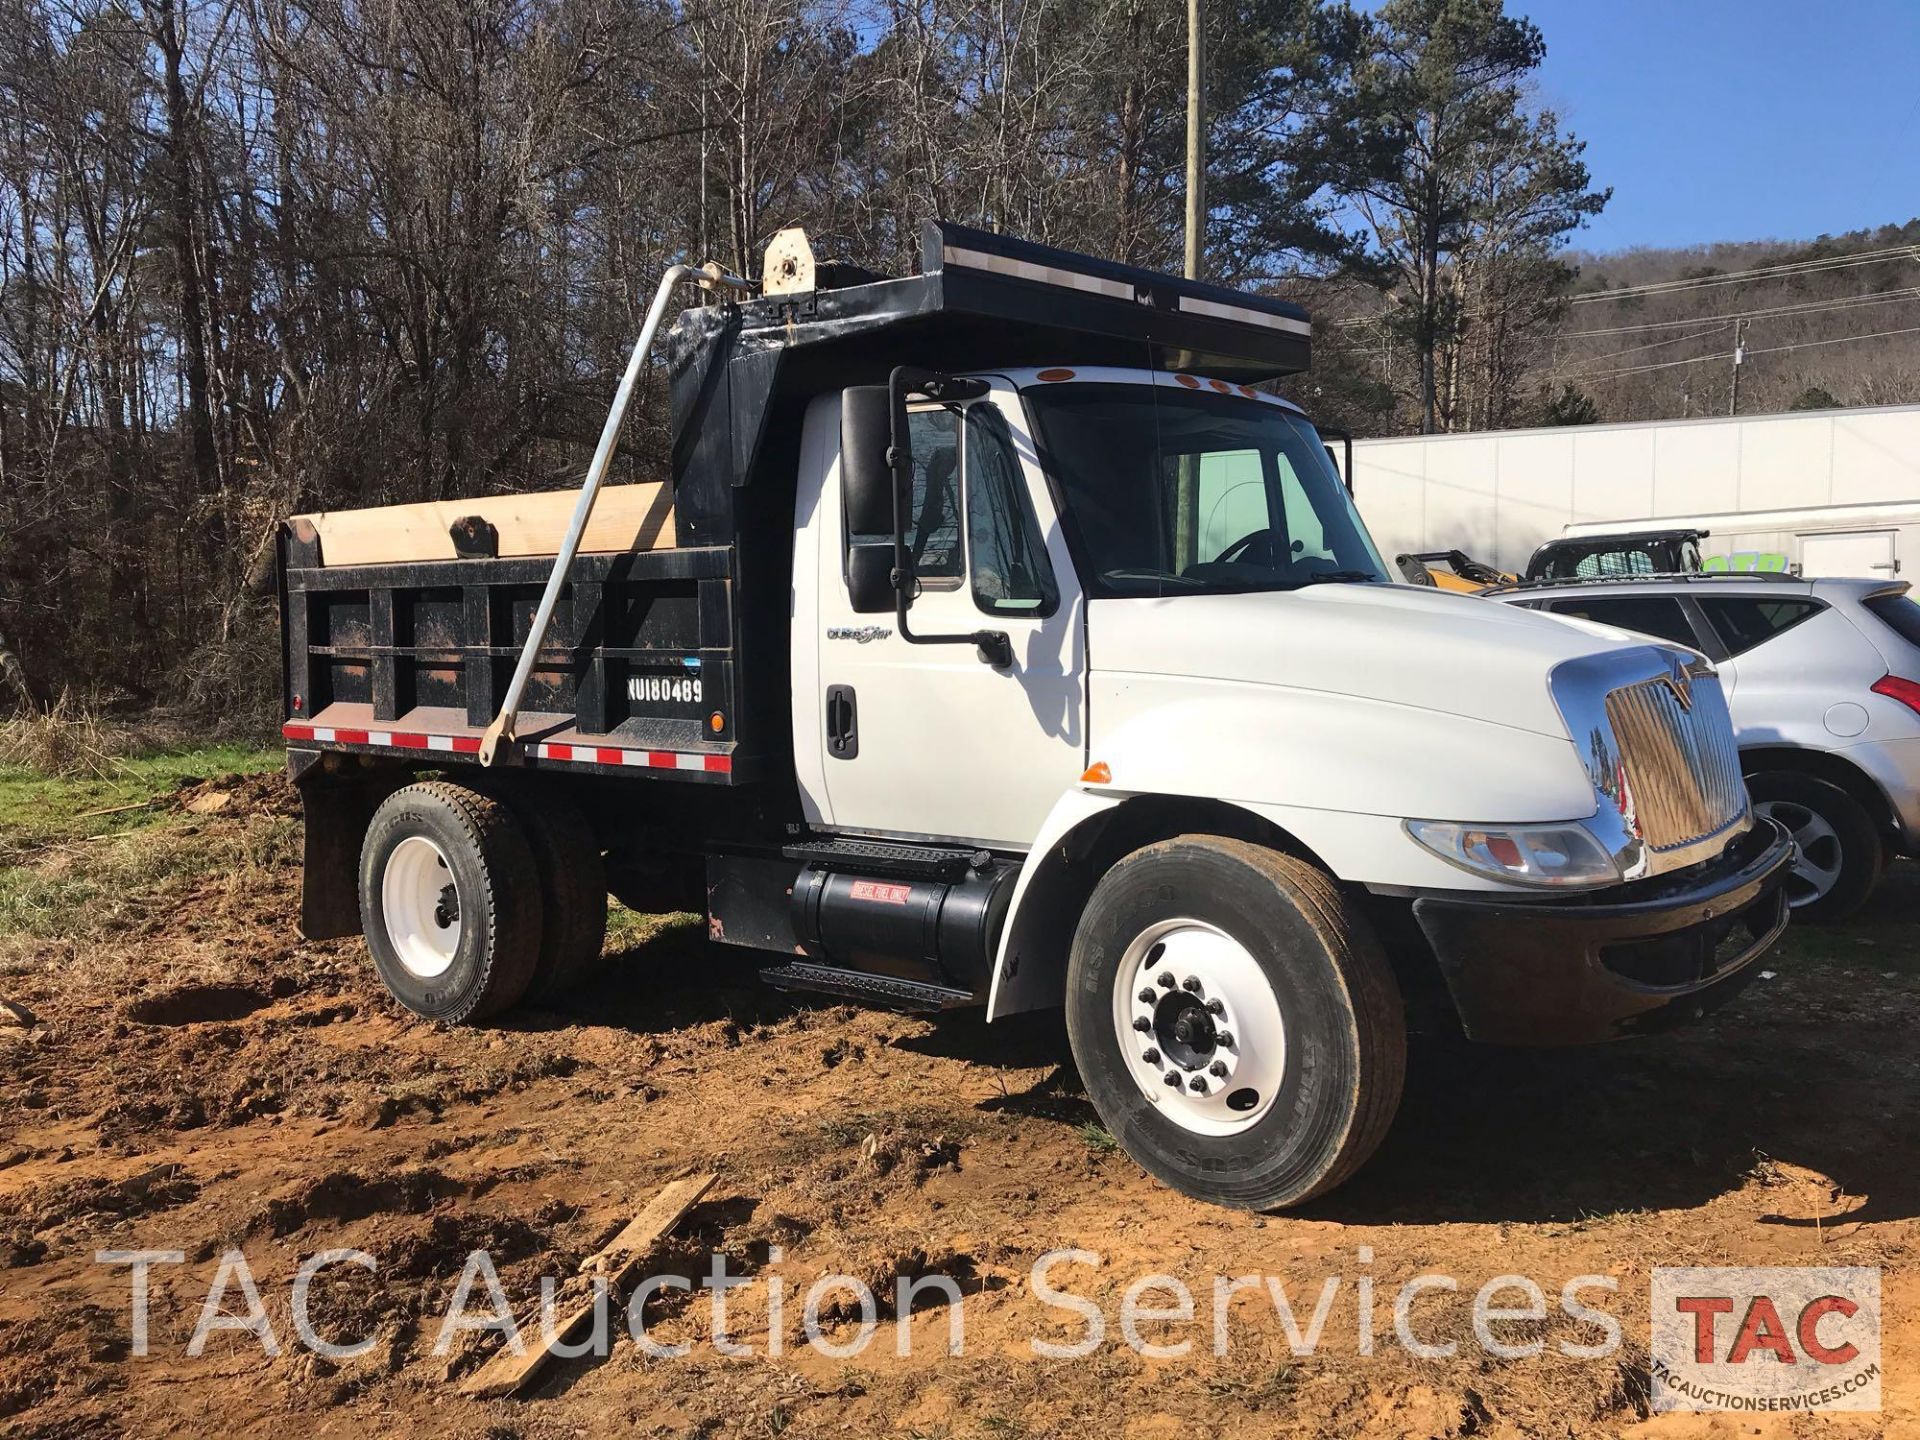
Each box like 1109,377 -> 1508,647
1114,920 -> 1286,1135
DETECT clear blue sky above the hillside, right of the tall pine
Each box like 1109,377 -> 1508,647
1507,0 -> 1920,250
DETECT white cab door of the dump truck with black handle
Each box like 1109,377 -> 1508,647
795,380 -> 1087,847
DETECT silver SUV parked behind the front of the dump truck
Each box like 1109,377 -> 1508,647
1484,574 -> 1920,920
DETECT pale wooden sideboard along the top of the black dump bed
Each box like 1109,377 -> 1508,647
294,480 -> 674,564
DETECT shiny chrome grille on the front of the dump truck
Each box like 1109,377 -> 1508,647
1607,672 -> 1747,851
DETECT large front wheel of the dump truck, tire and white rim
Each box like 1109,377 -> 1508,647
1066,835 -> 1407,1210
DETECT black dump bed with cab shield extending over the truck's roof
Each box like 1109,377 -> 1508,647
280,225 -> 1309,785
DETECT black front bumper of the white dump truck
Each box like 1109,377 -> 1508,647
1413,820 -> 1793,1044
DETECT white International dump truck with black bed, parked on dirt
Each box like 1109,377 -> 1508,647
280,223 -> 1791,1210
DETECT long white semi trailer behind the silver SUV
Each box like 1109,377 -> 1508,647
1352,405 -> 1920,578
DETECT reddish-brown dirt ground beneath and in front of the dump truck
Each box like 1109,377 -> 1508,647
0,776 -> 1920,1440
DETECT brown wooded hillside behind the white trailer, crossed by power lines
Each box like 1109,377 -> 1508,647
1286,219 -> 1920,434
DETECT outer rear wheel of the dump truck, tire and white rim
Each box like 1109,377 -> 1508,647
359,780 -> 541,1025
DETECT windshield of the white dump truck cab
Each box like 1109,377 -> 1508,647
1025,384 -> 1388,595
